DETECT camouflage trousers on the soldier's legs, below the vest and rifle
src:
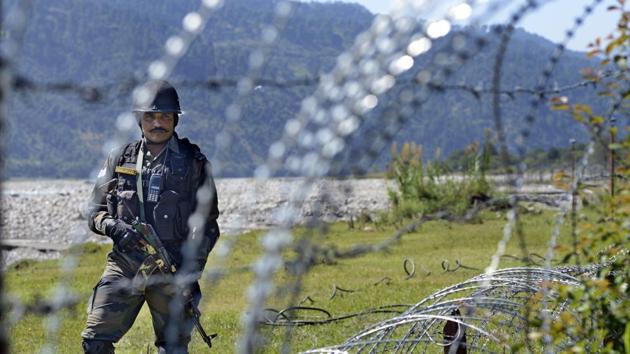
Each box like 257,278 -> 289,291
81,250 -> 201,348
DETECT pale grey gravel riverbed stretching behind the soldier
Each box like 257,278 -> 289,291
0,178 -> 388,266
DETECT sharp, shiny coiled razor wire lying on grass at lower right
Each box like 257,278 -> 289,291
305,268 -> 579,353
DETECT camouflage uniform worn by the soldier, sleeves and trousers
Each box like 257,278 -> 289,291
81,134 -> 219,353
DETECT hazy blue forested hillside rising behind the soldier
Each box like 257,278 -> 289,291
3,0 -> 608,178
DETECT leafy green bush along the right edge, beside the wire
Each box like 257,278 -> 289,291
529,0 -> 630,353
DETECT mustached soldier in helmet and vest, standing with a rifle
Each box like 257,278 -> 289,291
81,81 -> 219,353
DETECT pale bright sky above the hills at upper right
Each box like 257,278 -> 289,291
303,0 -> 618,51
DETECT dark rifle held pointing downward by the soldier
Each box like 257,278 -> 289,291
131,219 -> 217,348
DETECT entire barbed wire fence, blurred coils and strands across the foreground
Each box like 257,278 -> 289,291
0,0 -> 624,353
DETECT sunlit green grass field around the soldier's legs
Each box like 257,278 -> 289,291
6,212 -> 570,353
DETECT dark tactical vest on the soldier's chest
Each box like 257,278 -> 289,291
107,139 -> 205,243
